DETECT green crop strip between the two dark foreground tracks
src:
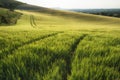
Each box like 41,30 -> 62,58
0,32 -> 85,80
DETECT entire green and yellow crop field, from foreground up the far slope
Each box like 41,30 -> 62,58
0,10 -> 120,80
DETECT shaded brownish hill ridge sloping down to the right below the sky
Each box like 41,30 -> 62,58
18,4 -> 120,21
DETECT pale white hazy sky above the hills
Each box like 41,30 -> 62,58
18,0 -> 120,9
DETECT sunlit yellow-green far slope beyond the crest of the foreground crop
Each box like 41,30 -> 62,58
0,7 -> 120,30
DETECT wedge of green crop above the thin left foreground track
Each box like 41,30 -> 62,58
0,31 -> 59,59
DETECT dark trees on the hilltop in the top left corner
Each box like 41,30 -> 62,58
0,0 -> 22,11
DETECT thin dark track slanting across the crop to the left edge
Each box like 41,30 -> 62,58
0,32 -> 63,60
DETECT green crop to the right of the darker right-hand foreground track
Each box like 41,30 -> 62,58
68,33 -> 120,80
